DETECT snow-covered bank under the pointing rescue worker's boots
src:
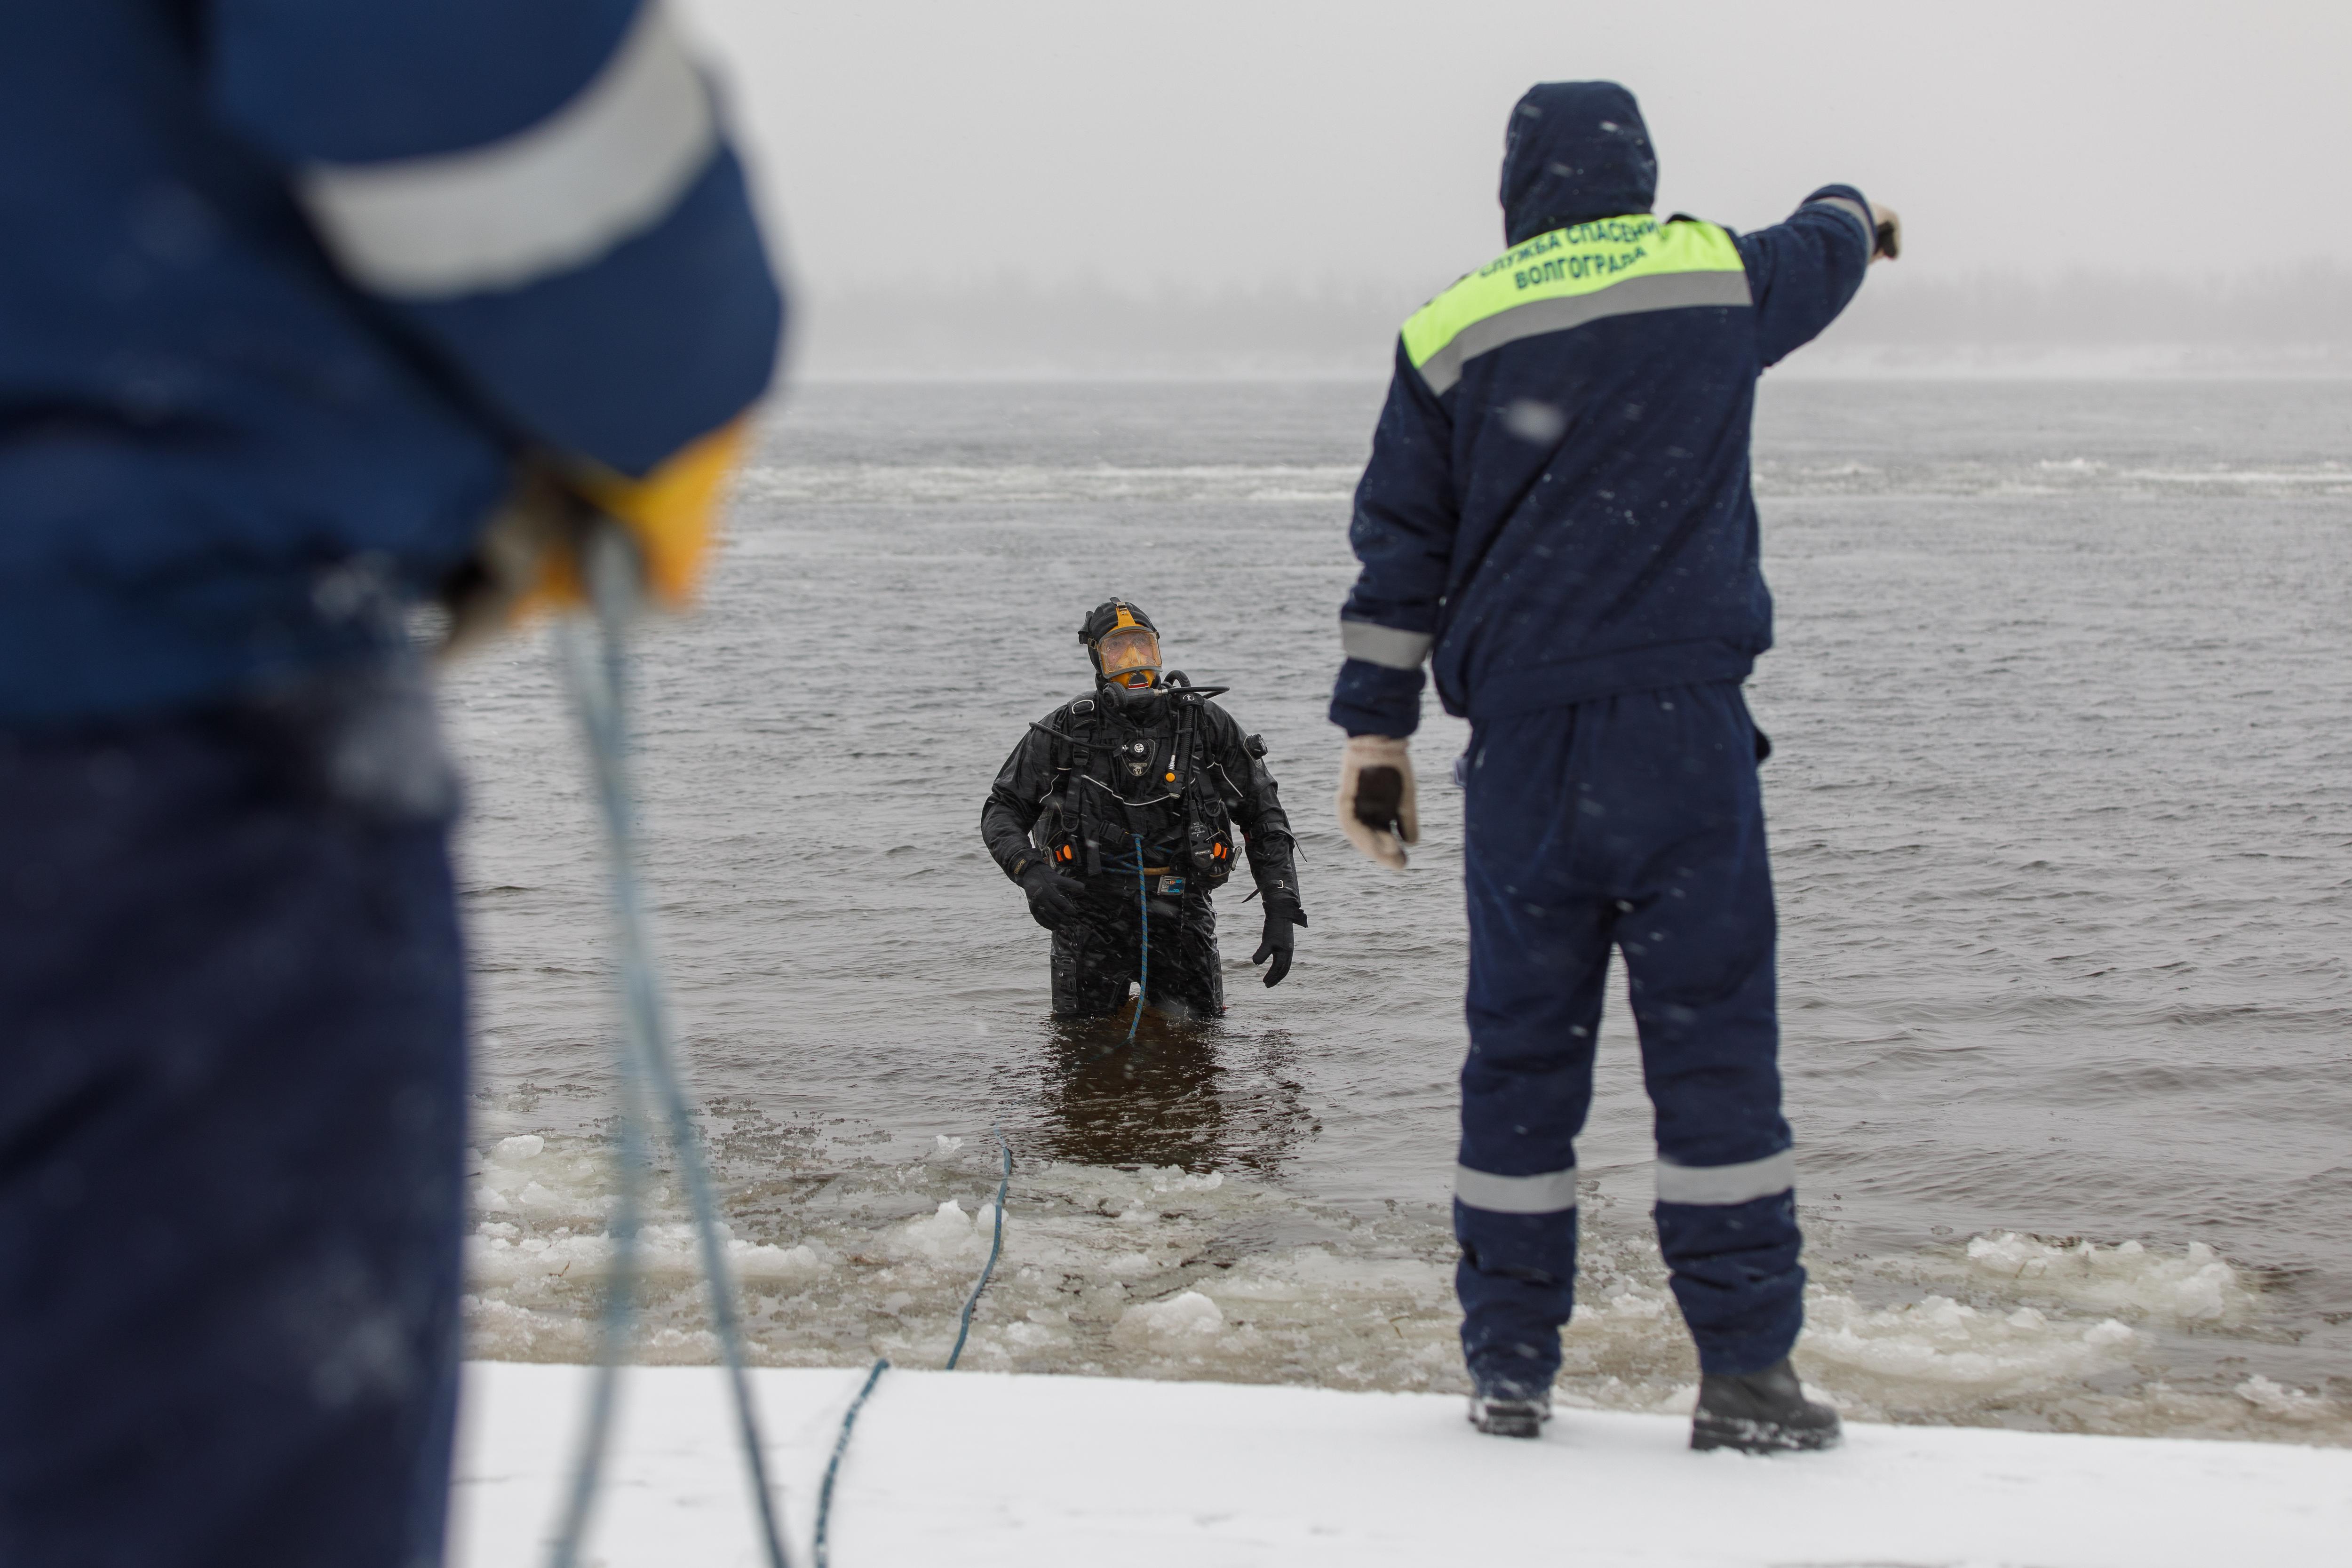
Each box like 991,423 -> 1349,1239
454,1361 -> 2352,1568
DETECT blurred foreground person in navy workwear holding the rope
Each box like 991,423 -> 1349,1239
0,0 -> 783,1568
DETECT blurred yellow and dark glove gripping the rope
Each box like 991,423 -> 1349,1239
442,416 -> 750,653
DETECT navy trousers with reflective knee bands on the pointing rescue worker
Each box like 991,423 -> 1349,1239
1454,682 -> 1804,1394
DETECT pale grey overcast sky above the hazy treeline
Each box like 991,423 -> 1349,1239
682,0 -> 2352,289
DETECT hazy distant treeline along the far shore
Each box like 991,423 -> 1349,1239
800,263 -> 2352,376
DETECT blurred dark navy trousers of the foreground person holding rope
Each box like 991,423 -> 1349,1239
0,689 -> 466,1568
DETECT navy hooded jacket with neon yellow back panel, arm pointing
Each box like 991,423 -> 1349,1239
1331,82 -> 1872,736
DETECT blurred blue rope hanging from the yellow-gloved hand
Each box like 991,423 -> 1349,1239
548,524 -> 790,1568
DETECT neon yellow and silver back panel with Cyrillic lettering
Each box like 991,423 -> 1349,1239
1404,214 -> 1750,395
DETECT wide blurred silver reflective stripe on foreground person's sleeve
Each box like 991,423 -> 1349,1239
296,0 -> 720,299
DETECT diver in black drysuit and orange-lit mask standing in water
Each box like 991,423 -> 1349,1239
981,599 -> 1308,1018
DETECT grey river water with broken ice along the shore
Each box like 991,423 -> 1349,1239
449,381 -> 2352,1443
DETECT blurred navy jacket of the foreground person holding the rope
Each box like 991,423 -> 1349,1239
0,0 -> 783,724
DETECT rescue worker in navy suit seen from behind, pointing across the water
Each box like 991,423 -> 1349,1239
1331,82 -> 1900,1450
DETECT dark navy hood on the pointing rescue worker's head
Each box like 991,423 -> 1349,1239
1503,82 -> 1658,245
